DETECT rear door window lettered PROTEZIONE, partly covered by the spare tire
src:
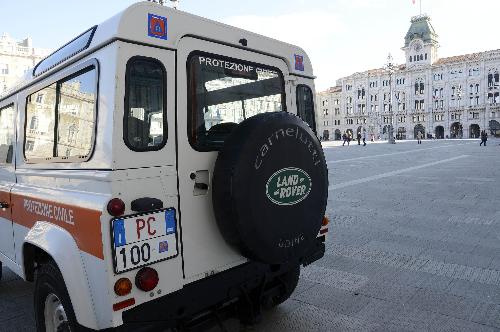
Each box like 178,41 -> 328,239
187,53 -> 286,151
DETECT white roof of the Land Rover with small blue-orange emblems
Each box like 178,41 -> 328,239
0,1 -> 314,101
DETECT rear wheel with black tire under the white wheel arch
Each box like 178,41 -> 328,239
34,261 -> 80,332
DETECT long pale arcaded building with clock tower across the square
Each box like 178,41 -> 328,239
317,15 -> 500,140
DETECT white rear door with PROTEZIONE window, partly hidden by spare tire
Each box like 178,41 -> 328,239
177,37 -> 290,282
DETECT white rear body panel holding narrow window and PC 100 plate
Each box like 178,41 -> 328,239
111,42 -> 182,294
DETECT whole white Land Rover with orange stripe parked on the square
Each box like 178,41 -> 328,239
0,2 -> 328,332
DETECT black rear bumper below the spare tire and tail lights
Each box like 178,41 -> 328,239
112,238 -> 325,331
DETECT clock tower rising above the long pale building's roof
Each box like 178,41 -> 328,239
402,14 -> 439,68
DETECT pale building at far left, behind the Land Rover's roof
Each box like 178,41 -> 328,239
0,33 -> 50,93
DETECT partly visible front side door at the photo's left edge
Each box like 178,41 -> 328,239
0,104 -> 16,261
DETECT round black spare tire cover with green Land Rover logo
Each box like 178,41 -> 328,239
212,112 -> 328,264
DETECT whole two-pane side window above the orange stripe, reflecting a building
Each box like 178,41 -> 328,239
24,66 -> 97,162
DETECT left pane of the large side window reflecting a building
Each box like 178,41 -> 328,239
24,83 -> 57,160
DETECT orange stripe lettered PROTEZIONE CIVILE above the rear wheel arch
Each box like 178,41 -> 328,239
12,194 -> 104,259
